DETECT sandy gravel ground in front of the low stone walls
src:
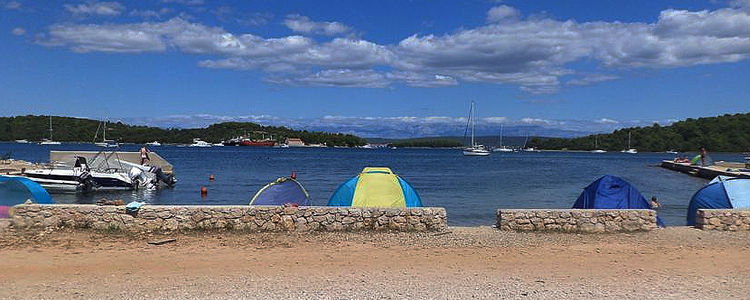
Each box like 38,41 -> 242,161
0,227 -> 750,299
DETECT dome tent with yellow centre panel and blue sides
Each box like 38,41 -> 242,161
328,167 -> 422,207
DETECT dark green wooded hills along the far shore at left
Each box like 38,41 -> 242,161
0,115 -> 367,147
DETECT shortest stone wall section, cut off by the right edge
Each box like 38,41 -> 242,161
695,209 -> 750,231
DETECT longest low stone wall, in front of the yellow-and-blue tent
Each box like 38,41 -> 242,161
11,204 -> 447,233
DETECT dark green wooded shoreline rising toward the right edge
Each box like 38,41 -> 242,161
529,113 -> 750,152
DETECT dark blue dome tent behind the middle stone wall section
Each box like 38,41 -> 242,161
573,175 -> 664,227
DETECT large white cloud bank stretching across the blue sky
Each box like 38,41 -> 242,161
39,4 -> 750,94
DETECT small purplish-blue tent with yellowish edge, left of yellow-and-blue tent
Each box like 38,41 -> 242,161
250,177 -> 310,206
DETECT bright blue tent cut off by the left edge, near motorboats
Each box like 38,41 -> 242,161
0,175 -> 52,218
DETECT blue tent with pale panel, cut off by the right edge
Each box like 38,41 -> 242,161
687,176 -> 750,226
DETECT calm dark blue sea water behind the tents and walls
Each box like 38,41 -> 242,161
0,143 -> 742,225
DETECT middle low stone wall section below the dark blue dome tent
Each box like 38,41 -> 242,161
497,209 -> 657,233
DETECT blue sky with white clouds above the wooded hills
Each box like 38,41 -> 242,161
0,0 -> 750,137
